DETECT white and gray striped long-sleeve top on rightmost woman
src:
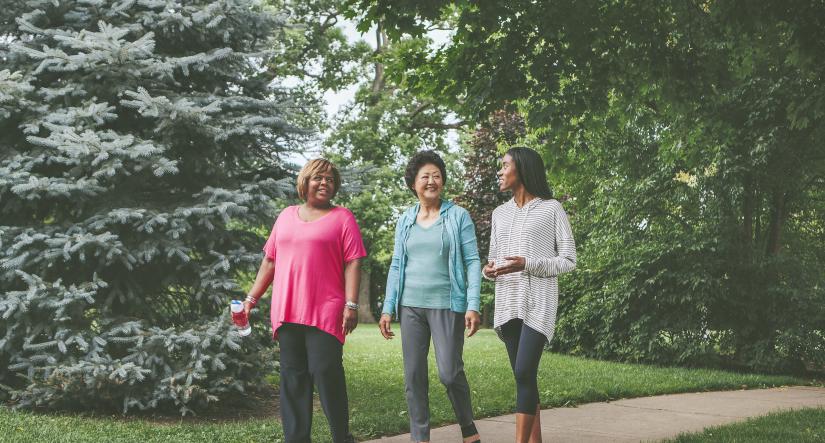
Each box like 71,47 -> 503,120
484,198 -> 576,342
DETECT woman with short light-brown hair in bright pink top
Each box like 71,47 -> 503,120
244,159 -> 366,443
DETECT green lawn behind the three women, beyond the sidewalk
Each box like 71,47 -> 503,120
0,325 -> 808,443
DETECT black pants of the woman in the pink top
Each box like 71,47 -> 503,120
278,323 -> 351,443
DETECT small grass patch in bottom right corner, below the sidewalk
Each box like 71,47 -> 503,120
669,408 -> 825,443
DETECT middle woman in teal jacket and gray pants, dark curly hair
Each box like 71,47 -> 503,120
378,151 -> 481,442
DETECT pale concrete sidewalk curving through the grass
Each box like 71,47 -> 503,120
372,386 -> 825,443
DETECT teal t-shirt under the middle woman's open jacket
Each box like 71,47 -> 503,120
401,217 -> 450,309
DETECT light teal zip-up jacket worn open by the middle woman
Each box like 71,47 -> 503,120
382,200 -> 481,318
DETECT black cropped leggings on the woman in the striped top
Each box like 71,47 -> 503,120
501,318 -> 547,415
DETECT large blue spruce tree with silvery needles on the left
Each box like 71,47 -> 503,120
0,0 -> 317,413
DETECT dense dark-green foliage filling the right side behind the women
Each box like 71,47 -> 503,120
353,0 -> 825,371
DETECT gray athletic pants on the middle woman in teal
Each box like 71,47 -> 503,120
400,306 -> 473,441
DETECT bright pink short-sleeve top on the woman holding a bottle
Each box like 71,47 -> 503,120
264,206 -> 367,343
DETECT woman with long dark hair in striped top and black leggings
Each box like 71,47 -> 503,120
483,147 -> 576,443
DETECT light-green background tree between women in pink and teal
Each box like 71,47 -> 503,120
325,26 -> 465,315
